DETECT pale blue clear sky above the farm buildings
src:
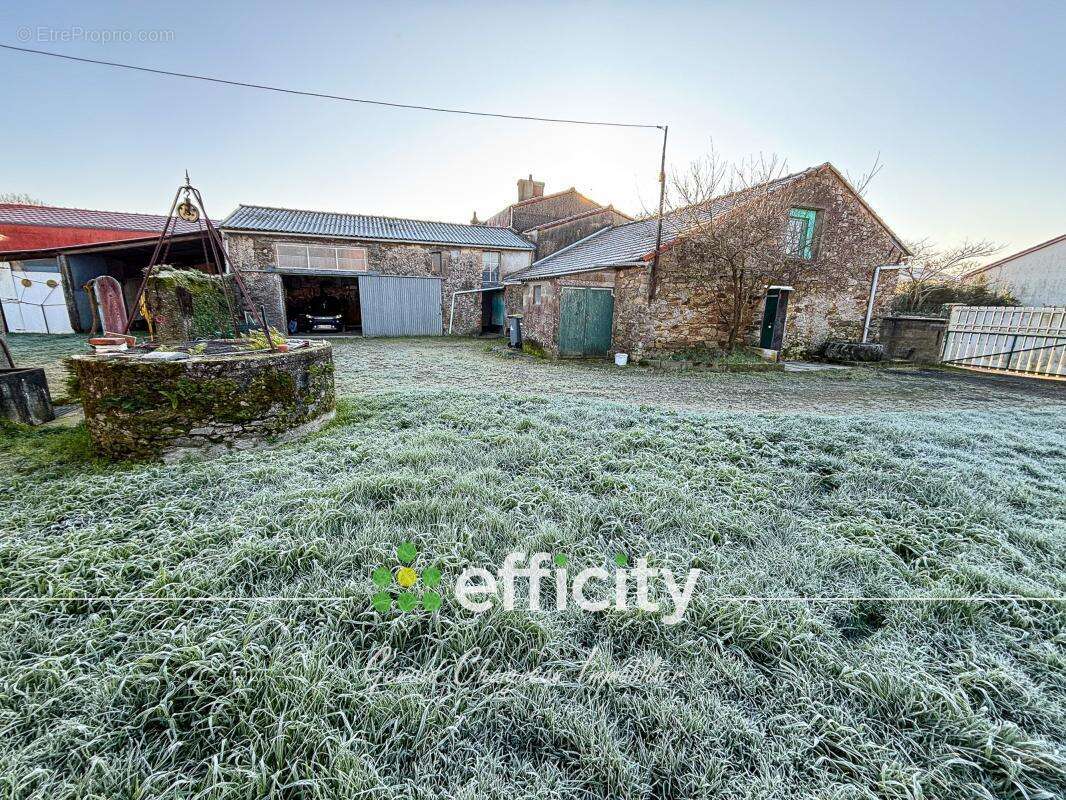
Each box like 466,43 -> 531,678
0,0 -> 1066,258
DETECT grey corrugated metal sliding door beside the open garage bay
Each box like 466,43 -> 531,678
359,275 -> 441,336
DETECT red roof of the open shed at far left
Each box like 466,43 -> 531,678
0,203 -> 210,253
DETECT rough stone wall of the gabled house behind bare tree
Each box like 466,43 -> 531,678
613,171 -> 902,358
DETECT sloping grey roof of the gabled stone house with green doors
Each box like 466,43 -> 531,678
507,167 -> 819,281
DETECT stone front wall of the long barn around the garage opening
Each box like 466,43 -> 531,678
226,234 -> 532,334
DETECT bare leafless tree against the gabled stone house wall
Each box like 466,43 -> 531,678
664,149 -> 809,350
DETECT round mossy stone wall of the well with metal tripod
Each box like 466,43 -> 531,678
69,341 -> 336,461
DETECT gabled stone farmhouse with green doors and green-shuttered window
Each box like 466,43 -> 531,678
506,163 -> 909,358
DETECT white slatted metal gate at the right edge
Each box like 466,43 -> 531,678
940,305 -> 1066,377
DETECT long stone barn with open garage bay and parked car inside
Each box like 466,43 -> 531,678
220,205 -> 534,336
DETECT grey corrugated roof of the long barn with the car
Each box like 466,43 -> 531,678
220,205 -> 533,250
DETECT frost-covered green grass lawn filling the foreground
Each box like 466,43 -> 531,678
0,334 -> 1066,800
